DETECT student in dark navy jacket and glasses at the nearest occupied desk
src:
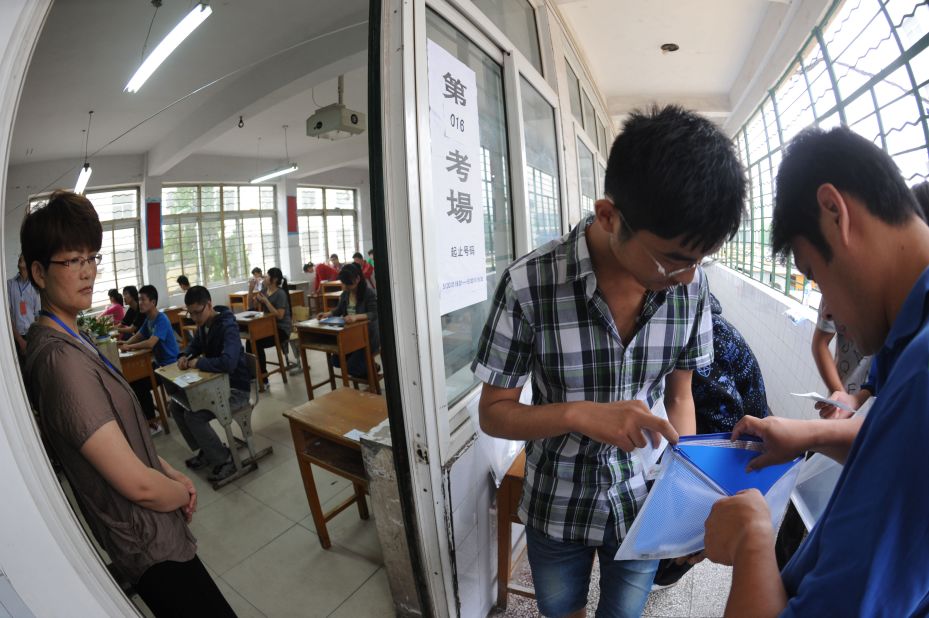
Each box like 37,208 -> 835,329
169,285 -> 249,481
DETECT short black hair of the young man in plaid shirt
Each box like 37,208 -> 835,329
604,105 -> 745,251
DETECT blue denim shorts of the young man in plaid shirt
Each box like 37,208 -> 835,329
526,516 -> 658,618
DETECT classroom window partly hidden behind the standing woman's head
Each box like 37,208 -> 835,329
29,187 -> 142,308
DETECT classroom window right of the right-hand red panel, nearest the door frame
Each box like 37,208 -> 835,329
297,187 -> 364,264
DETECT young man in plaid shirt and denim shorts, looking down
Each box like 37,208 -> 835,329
472,107 -> 745,616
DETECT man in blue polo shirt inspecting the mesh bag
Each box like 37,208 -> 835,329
706,127 -> 929,616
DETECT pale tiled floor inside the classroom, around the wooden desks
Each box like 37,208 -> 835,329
136,354 -> 393,618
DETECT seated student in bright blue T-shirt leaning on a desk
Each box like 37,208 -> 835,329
119,285 -> 178,436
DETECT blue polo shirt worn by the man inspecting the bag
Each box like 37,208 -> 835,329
781,269 -> 929,617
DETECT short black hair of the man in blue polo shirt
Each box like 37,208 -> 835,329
771,127 -> 919,262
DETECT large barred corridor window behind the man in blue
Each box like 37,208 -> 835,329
718,0 -> 929,304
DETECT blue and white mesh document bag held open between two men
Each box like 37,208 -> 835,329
616,433 -> 802,560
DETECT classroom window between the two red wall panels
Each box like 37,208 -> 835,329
161,185 -> 279,293
